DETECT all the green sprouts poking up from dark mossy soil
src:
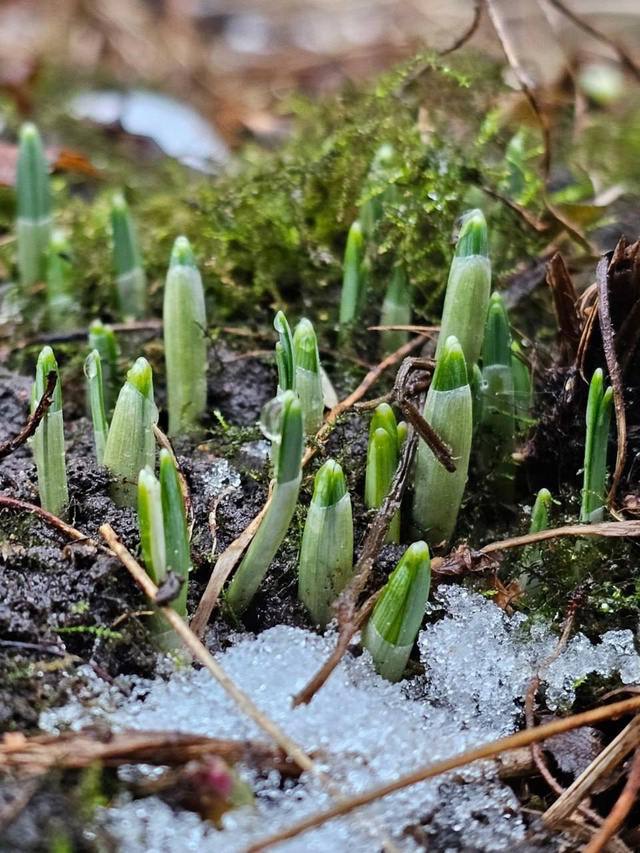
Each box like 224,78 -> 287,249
17,125 -> 612,681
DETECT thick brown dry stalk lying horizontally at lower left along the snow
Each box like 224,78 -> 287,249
0,729 -> 294,774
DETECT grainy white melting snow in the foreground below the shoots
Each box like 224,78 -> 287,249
41,587 -> 640,853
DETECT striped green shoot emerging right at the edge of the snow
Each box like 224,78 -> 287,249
362,541 -> 431,681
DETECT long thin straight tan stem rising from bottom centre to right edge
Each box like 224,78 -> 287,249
247,696 -> 640,853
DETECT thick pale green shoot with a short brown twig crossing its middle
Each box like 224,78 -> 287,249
412,335 -> 473,545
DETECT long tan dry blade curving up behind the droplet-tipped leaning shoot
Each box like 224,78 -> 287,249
191,334 -> 426,636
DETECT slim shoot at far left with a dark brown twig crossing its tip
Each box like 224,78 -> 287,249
31,346 -> 69,516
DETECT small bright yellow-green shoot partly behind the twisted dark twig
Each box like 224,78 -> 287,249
364,403 -> 400,542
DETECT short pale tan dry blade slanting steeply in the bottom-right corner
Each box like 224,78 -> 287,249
542,716 -> 640,829
